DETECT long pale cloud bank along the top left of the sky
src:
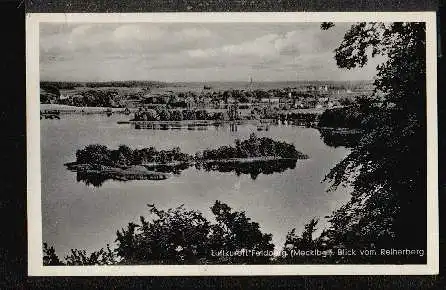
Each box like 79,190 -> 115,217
40,24 -> 216,54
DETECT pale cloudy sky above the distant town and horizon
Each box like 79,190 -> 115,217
40,23 -> 376,82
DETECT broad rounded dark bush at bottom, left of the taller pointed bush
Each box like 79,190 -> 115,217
116,205 -> 210,264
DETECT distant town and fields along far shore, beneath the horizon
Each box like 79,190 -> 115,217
40,81 -> 373,121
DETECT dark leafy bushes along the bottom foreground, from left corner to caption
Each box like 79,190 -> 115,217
43,200 -> 274,265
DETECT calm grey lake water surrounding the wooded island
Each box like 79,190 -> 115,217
40,114 -> 349,258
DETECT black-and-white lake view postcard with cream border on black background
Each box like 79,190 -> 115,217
26,12 -> 438,276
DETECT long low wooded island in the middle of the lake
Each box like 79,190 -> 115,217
65,133 -> 308,186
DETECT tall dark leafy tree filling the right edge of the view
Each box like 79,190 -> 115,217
318,23 -> 426,262
